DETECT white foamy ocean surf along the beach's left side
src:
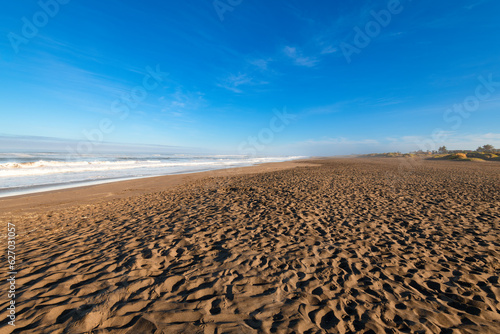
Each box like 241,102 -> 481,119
0,153 -> 303,197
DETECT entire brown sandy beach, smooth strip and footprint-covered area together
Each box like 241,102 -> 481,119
0,158 -> 500,334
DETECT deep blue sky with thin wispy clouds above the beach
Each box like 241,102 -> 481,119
0,0 -> 500,155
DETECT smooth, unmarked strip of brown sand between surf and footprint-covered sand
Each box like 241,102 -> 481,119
0,159 -> 310,218
